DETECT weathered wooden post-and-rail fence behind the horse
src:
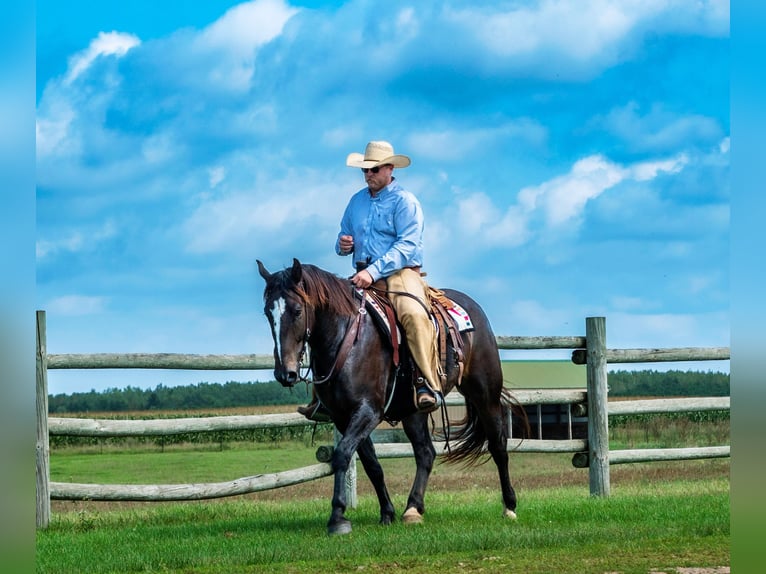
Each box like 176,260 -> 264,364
36,311 -> 730,528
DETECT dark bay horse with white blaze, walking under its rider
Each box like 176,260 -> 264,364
257,259 -> 526,534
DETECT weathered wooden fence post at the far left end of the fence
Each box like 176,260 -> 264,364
35,311 -> 51,528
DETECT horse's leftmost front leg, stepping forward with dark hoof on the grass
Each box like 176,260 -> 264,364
327,403 -> 382,534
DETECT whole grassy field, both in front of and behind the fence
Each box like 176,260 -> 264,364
37,410 -> 730,574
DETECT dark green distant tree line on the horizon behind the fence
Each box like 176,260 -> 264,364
48,370 -> 730,414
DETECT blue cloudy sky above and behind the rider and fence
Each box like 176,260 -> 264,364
36,0 -> 730,393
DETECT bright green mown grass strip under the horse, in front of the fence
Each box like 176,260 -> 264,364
37,479 -> 729,574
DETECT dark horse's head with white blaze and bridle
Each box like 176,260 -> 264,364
257,259 -> 311,387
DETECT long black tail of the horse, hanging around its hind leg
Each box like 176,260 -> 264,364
443,387 -> 530,467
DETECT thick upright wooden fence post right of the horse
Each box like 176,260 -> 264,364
585,317 -> 609,496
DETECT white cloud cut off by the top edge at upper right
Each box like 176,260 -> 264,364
443,0 -> 729,78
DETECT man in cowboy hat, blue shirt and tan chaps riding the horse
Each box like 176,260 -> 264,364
298,141 -> 443,424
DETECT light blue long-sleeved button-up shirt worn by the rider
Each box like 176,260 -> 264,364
335,179 -> 424,281
